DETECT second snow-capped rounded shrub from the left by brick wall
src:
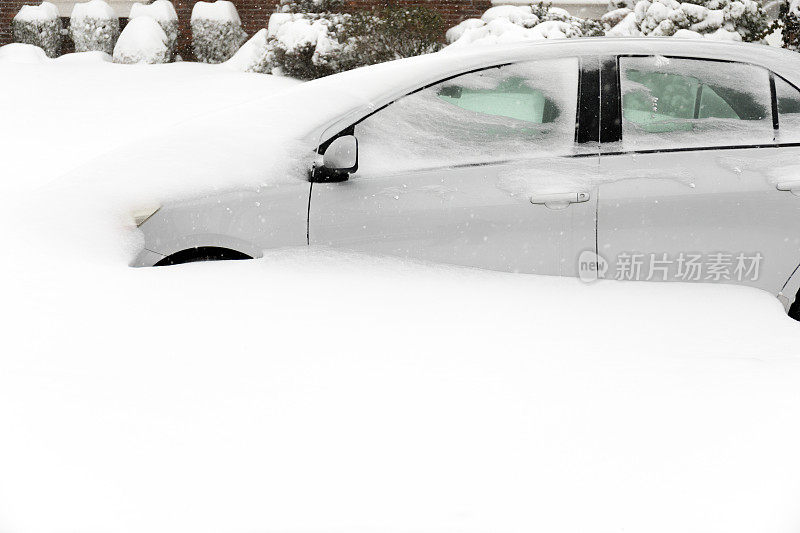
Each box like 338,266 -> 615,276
69,0 -> 119,54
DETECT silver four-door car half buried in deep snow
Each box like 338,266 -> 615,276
134,38 -> 800,316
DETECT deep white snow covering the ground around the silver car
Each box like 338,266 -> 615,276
0,46 -> 800,533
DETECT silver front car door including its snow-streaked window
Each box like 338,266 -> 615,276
309,58 -> 599,275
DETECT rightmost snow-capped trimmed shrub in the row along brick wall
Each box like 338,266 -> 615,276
192,0 -> 247,63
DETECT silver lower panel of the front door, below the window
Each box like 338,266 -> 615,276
309,157 -> 597,276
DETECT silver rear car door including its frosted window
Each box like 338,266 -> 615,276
598,56 -> 800,296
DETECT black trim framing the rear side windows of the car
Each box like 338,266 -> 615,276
600,54 -> 800,155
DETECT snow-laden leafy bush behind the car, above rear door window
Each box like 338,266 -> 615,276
601,0 -> 768,41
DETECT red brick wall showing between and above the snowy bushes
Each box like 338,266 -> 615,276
0,0 -> 491,59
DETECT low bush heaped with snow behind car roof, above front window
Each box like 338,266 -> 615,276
445,4 -> 603,48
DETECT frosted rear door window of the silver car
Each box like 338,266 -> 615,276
620,56 -> 774,149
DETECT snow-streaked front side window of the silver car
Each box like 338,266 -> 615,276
355,58 -> 578,176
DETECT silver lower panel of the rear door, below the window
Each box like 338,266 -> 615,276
598,148 -> 800,294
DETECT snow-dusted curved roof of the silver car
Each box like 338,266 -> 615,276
290,37 -> 800,142
